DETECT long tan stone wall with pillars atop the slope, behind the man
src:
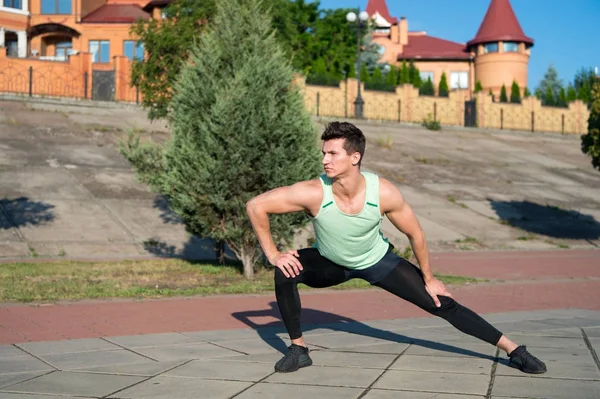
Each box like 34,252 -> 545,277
296,78 -> 589,134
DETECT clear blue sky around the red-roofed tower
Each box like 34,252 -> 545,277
320,0 -> 600,91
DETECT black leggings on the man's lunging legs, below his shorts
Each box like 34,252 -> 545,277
275,248 -> 502,346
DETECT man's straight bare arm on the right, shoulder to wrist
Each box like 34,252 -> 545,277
379,178 -> 434,282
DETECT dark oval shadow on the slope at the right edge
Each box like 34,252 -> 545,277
488,199 -> 600,240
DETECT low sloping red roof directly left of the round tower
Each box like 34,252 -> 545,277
398,33 -> 470,60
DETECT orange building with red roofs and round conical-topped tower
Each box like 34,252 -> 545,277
366,0 -> 533,95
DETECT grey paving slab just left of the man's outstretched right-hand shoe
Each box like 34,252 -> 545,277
390,355 -> 493,375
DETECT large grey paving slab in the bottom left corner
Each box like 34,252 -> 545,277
4,371 -> 144,397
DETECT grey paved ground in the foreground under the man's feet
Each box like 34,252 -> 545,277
0,309 -> 600,399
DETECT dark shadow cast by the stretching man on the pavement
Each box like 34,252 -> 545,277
231,301 -> 497,361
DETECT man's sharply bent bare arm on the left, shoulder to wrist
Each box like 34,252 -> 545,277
246,180 -> 323,263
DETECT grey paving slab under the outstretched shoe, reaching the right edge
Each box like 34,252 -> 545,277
496,360 -> 600,381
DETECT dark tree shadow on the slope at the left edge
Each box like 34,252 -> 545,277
0,197 -> 55,230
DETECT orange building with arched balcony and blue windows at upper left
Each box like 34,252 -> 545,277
0,0 -> 169,64
